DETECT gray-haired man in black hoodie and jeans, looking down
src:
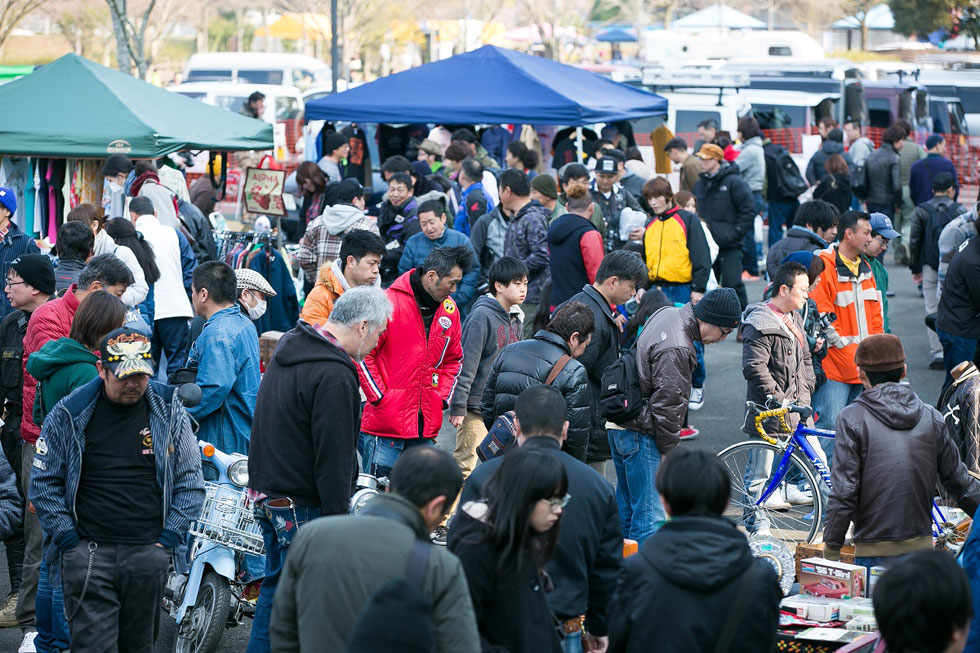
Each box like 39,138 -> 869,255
248,286 -> 392,651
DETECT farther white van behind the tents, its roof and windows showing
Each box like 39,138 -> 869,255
183,52 -> 330,91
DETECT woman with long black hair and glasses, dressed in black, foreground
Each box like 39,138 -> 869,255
449,449 -> 571,653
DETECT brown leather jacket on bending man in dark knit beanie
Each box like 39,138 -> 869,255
623,304 -> 701,454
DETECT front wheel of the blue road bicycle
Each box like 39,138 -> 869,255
718,442 -> 823,551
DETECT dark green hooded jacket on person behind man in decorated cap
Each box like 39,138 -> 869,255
27,338 -> 99,424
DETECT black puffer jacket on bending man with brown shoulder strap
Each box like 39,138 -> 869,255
480,331 -> 592,460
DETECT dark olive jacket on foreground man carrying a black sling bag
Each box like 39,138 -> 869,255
269,494 -> 480,653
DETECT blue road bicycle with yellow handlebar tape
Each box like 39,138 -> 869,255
718,400 -> 969,551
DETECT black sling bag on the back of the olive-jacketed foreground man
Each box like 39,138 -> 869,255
347,539 -> 436,653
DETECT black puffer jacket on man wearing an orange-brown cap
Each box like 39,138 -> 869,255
694,164 -> 756,249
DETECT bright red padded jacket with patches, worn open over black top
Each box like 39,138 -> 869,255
358,270 -> 463,438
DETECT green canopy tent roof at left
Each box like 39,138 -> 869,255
0,54 -> 273,159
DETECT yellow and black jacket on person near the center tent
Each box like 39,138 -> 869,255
643,206 -> 711,293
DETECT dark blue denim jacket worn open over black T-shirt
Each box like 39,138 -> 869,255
29,378 -> 204,551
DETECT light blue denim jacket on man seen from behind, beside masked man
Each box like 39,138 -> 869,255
187,303 -> 261,454
